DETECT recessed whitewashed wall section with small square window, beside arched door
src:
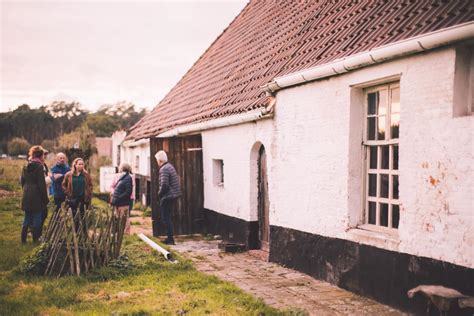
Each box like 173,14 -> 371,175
202,119 -> 273,221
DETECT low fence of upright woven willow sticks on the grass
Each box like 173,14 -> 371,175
44,208 -> 127,277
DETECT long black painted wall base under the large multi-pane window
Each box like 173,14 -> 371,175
270,226 -> 474,315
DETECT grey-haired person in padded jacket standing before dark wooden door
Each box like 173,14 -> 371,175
155,150 -> 181,245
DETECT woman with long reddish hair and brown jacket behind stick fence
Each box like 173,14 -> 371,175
62,158 -> 92,216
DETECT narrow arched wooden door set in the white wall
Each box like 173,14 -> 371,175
258,146 -> 270,251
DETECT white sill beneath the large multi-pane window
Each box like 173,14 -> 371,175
347,225 -> 400,251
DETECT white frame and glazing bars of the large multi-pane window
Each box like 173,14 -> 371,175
358,81 -> 400,235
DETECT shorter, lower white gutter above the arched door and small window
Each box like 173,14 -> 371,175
156,97 -> 276,138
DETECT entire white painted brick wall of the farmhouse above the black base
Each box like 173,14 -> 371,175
203,48 -> 474,267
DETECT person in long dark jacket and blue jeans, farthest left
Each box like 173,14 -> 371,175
21,146 -> 49,243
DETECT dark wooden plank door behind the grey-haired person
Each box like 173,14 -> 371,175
150,135 -> 204,236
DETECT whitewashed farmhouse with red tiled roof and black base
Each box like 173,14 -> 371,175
127,0 -> 474,308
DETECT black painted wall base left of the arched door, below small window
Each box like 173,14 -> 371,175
203,209 -> 258,249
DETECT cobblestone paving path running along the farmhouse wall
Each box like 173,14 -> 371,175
172,239 -> 403,315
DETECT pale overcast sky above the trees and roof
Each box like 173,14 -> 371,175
0,0 -> 247,112
